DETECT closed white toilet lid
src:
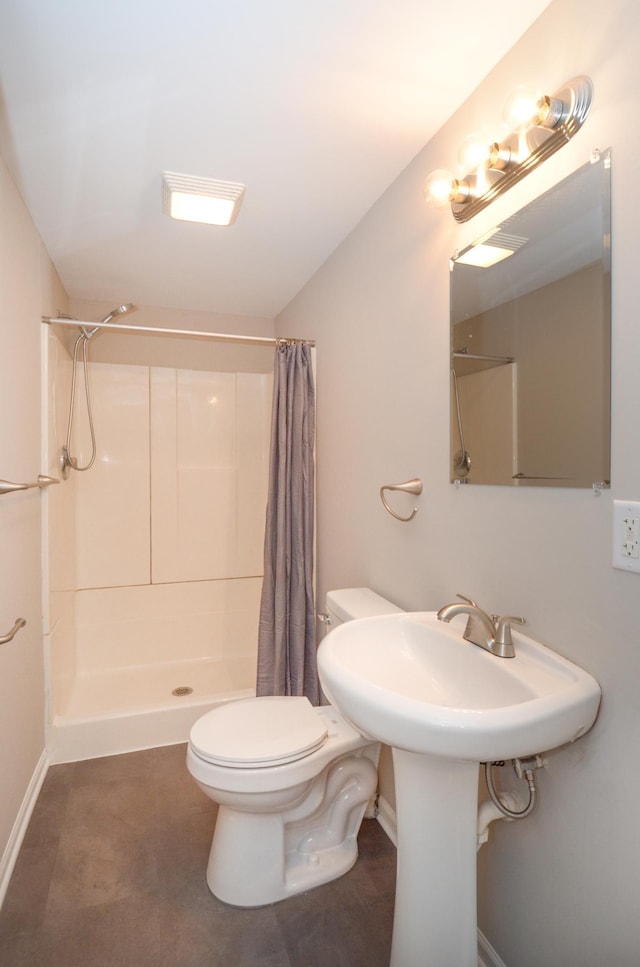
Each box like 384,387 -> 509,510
190,696 -> 327,769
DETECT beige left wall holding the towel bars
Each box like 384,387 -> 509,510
0,160 -> 65,882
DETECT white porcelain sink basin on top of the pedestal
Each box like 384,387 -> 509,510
318,612 -> 600,762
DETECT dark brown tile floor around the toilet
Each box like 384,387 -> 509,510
0,745 -> 395,967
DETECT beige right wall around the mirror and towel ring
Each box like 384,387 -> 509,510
277,0 -> 640,967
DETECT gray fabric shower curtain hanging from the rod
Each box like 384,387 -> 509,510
256,341 -> 320,705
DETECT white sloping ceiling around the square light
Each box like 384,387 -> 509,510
0,0 -> 549,317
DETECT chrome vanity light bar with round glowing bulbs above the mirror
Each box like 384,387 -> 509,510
425,75 -> 593,222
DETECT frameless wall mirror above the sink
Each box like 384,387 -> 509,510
451,150 -> 611,487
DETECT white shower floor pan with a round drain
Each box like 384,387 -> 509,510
48,656 -> 256,763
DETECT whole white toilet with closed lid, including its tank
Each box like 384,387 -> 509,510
187,588 -> 402,907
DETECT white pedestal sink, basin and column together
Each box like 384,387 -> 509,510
318,612 -> 600,967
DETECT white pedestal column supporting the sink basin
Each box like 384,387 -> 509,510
391,749 -> 478,967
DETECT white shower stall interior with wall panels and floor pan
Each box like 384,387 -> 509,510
42,307 -> 275,762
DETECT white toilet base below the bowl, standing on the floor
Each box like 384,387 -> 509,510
207,747 -> 377,907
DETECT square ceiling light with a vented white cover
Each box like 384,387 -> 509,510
162,171 -> 244,225
